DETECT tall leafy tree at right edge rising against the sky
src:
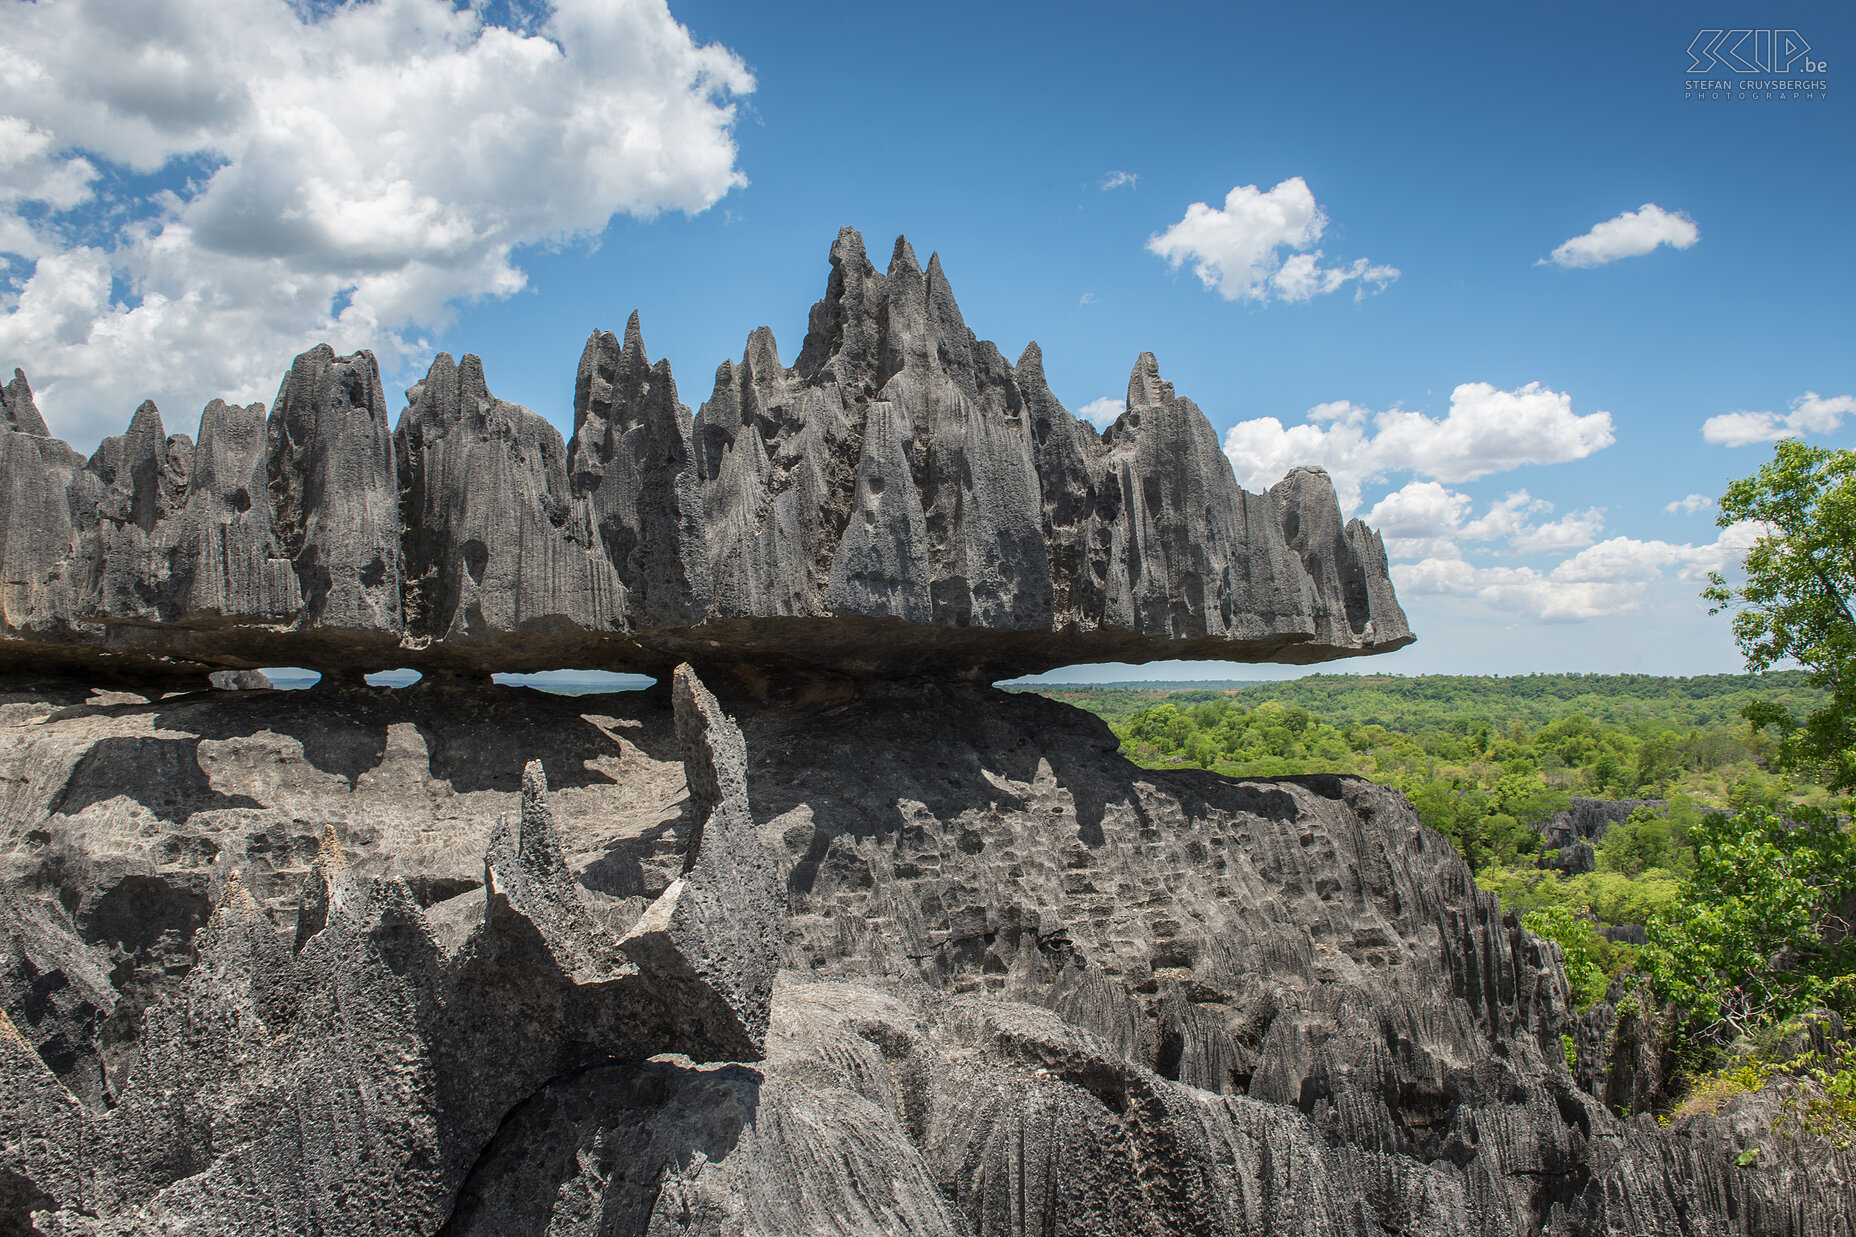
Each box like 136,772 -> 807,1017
1702,438 -> 1856,789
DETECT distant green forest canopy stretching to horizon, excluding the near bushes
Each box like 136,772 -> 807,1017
1039,671 -> 1830,958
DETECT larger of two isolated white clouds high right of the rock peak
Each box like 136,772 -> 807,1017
1147,176 -> 1399,303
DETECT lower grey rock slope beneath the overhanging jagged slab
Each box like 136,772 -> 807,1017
0,674 -> 1856,1237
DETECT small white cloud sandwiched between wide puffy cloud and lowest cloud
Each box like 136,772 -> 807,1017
1364,481 -> 1605,559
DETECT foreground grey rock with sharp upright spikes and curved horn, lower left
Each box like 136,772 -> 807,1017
0,676 -> 783,1233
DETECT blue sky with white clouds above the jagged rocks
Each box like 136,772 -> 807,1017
0,0 -> 1856,678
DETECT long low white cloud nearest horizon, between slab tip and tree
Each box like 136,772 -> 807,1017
1392,522 -> 1761,622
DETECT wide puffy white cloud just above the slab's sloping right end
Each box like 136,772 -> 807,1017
1225,383 -> 1617,511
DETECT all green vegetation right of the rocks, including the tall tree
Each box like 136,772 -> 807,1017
1021,438 -> 1856,1121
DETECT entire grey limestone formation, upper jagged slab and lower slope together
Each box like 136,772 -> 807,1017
0,230 -> 1856,1237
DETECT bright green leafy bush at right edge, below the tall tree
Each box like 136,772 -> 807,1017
1643,808 -> 1856,1042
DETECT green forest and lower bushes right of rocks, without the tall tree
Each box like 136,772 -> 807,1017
1015,671 -> 1856,1129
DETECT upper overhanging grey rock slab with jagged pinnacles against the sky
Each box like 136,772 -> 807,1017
0,228 -> 1412,682
